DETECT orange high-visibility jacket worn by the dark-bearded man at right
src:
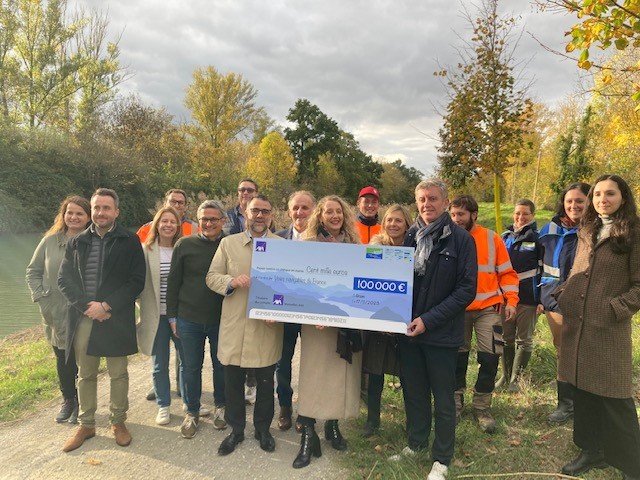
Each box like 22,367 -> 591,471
467,224 -> 520,311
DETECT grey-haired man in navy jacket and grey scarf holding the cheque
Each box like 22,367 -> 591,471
391,179 -> 478,480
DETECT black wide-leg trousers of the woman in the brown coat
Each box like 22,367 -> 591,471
573,388 -> 640,477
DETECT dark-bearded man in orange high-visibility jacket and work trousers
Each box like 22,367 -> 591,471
449,195 -> 519,433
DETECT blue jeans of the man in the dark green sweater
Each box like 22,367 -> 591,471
177,317 -> 226,415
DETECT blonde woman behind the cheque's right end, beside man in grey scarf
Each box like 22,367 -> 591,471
362,204 -> 413,437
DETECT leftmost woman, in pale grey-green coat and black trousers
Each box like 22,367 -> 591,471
27,195 -> 91,423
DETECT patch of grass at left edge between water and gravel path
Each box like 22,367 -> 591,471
0,326 -> 59,422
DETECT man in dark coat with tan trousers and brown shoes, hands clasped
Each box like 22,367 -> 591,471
58,188 -> 145,452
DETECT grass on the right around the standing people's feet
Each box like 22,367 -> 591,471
343,316 -> 640,480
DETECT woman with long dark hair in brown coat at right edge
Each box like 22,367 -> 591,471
554,175 -> 640,480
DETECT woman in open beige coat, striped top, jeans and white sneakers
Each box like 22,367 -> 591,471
137,207 -> 183,425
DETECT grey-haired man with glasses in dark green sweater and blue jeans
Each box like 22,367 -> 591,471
167,200 -> 227,438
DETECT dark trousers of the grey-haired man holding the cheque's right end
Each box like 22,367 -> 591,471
399,341 -> 458,465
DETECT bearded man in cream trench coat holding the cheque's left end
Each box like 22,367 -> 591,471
207,195 -> 283,455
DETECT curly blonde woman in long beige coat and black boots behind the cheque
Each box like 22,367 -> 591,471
293,195 -> 362,468
